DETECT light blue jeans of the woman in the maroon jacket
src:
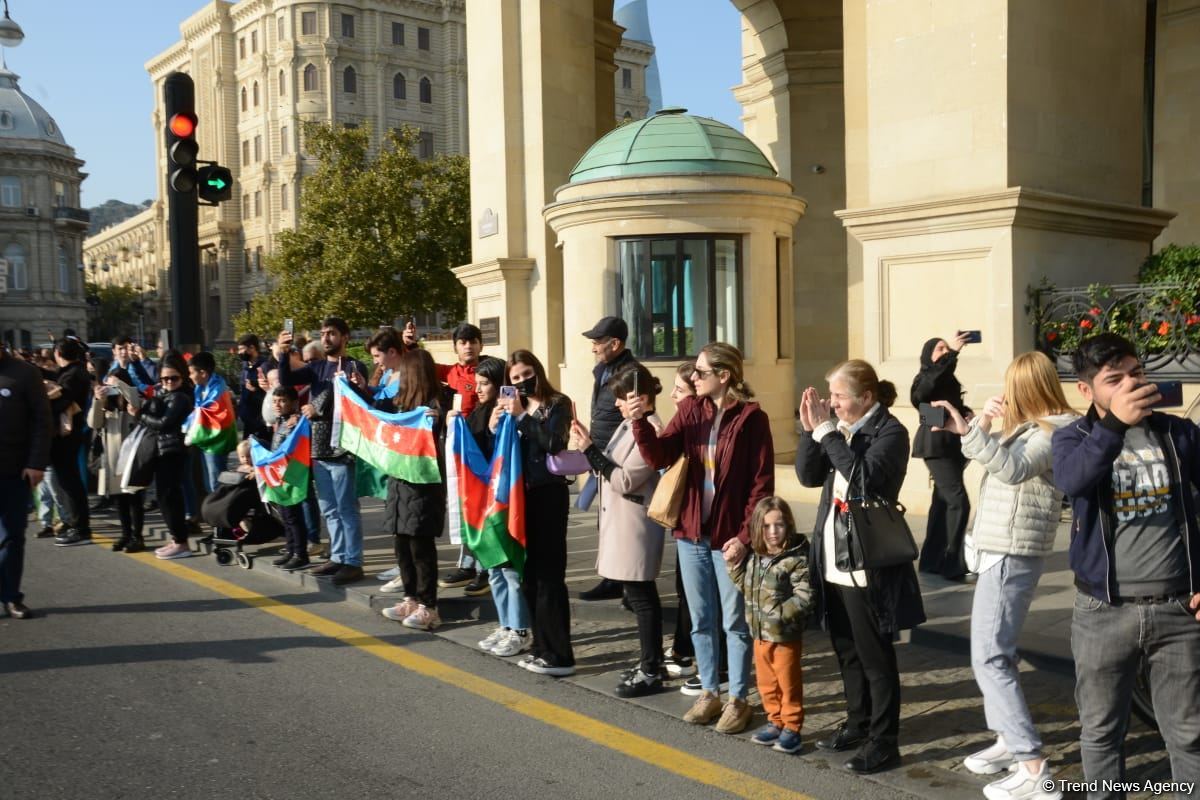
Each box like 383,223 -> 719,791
676,539 -> 750,699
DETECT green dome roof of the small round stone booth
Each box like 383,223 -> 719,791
569,108 -> 775,184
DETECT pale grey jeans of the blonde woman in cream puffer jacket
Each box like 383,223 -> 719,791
971,555 -> 1045,762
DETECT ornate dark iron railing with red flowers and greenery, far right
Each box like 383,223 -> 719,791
1028,283 -> 1200,380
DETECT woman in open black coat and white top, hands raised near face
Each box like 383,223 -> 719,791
796,360 -> 925,775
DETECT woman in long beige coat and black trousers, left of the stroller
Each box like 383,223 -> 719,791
88,368 -> 145,553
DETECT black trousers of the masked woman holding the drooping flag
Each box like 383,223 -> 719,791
522,483 -> 575,667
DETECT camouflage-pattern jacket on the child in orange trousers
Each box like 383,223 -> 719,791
727,536 -> 812,642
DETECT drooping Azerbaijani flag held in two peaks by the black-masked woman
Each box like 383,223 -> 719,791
446,414 -> 526,575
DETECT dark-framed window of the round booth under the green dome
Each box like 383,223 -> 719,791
618,236 -> 742,359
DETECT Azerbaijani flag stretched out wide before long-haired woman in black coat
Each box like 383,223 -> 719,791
330,375 -> 442,483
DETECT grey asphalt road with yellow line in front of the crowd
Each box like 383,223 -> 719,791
0,525 -> 926,800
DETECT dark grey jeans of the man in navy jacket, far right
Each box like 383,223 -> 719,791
1070,593 -> 1200,800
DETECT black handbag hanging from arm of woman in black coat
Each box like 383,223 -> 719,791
833,459 -> 917,572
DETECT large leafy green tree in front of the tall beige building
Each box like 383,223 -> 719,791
234,124 -> 470,333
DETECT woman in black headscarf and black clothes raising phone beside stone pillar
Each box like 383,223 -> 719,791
911,332 -> 972,581
